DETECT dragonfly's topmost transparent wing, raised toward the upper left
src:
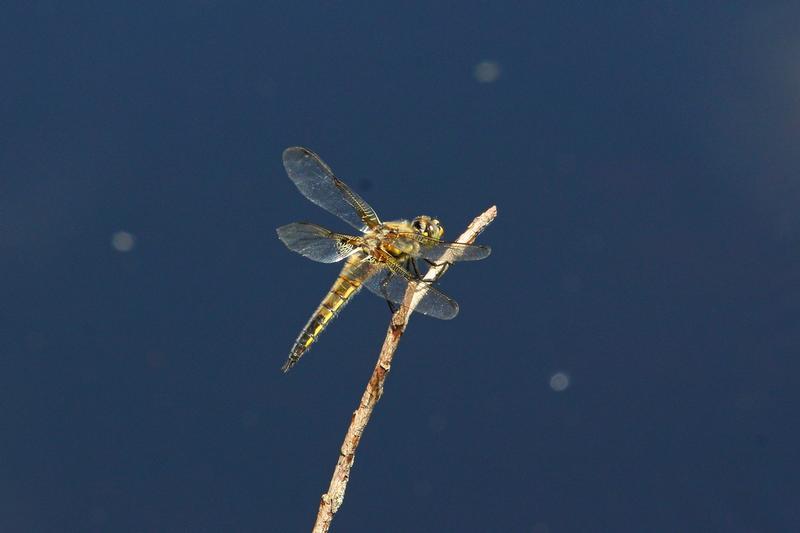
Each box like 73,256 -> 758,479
283,146 -> 380,231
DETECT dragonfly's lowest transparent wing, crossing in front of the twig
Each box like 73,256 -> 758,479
363,260 -> 458,320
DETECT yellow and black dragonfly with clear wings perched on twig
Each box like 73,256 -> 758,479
277,146 -> 491,372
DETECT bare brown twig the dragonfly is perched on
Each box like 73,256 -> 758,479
312,206 -> 497,533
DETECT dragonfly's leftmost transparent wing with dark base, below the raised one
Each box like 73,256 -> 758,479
277,222 -> 358,263
